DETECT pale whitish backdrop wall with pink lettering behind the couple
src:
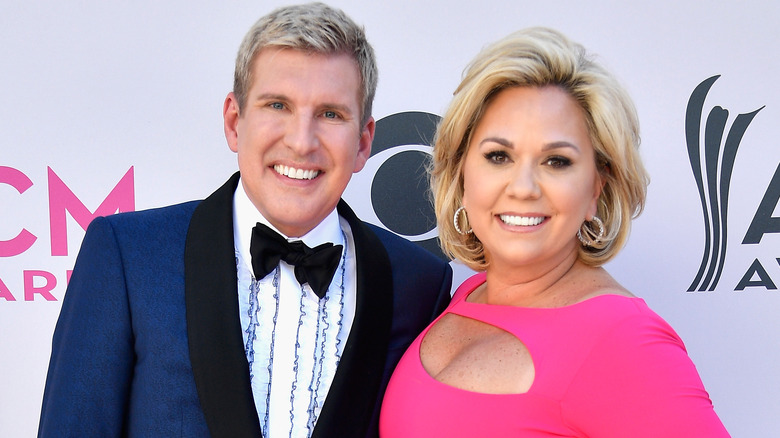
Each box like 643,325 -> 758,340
0,0 -> 780,437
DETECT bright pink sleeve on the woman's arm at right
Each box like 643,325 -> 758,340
561,296 -> 729,438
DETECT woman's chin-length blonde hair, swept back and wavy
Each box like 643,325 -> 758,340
431,27 -> 649,270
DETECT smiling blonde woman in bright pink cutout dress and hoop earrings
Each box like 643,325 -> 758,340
380,28 -> 728,438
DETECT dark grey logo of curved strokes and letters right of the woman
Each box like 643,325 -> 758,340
685,75 -> 780,292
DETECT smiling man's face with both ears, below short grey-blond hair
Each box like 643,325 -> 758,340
224,47 -> 375,237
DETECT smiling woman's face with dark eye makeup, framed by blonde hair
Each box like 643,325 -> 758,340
463,86 -> 602,267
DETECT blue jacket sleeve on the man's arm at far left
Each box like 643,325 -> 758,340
38,218 -> 135,437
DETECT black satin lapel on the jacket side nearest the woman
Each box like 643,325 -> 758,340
312,201 -> 393,438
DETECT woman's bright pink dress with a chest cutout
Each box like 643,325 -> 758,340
380,274 -> 729,438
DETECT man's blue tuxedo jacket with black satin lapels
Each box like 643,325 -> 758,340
38,174 -> 452,438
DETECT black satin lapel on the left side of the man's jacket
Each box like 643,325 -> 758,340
184,173 -> 260,438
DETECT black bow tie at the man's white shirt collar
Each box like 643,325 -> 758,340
249,222 -> 342,298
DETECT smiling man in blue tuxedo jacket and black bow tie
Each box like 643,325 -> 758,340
39,4 -> 452,438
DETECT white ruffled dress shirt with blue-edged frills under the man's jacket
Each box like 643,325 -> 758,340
233,181 -> 356,438
